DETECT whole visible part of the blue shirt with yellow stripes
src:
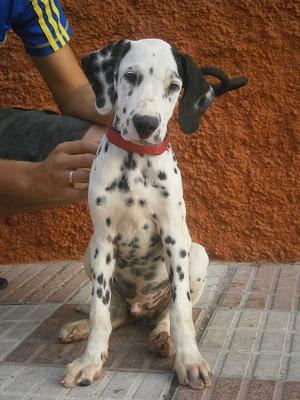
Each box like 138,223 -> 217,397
0,0 -> 71,56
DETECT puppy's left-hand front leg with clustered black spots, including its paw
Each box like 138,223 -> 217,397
62,236 -> 115,387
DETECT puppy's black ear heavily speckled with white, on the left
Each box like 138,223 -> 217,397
81,40 -> 131,115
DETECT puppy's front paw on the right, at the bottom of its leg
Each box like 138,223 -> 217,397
175,353 -> 212,390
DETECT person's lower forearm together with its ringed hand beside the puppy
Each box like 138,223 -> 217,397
0,125 -> 104,218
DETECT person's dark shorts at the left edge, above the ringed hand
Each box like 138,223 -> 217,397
0,108 -> 93,161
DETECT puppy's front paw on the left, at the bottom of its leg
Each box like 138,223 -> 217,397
61,353 -> 107,388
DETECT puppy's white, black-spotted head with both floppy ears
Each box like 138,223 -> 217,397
81,39 -> 218,144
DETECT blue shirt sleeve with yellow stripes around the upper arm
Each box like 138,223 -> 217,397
12,0 -> 72,56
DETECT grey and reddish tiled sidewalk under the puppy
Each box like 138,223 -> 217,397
0,262 -> 300,400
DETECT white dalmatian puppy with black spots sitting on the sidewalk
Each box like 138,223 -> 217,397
60,39 -> 218,389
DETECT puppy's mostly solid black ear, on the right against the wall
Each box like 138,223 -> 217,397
173,49 -> 215,133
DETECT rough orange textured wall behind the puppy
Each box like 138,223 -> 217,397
0,0 -> 300,263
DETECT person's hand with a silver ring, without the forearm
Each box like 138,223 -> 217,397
33,140 -> 99,203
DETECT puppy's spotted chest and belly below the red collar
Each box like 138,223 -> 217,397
89,139 -> 182,316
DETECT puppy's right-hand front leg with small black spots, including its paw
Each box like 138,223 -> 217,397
161,215 -> 211,389
